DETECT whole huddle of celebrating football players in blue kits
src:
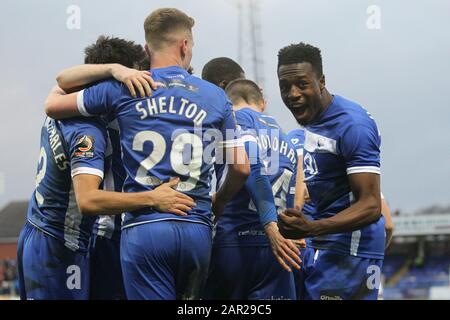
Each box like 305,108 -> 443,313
18,8 -> 392,300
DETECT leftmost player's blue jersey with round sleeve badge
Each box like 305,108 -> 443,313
27,118 -> 107,252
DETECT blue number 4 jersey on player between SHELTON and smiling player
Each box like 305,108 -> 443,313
214,108 -> 297,246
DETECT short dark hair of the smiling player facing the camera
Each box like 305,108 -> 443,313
278,42 -> 323,77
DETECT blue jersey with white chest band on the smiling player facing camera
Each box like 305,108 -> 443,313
303,95 -> 385,258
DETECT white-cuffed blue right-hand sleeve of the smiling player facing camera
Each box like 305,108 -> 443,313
340,124 -> 381,174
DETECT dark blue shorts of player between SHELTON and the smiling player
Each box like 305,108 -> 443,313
204,246 -> 296,300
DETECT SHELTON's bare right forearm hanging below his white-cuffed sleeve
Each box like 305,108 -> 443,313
212,146 -> 250,220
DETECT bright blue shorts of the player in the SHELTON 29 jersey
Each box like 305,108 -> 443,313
120,221 -> 212,300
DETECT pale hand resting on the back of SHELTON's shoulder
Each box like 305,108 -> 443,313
111,64 -> 160,98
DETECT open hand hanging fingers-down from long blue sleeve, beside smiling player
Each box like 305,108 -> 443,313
264,222 -> 302,272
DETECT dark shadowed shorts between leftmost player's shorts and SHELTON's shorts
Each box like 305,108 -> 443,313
89,235 -> 126,300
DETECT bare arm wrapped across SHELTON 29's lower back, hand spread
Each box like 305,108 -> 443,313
73,174 -> 195,216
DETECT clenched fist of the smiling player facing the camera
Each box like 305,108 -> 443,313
278,209 -> 312,239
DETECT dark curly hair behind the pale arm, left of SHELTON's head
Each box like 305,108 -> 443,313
84,35 -> 149,69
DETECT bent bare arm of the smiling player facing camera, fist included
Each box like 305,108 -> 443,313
278,173 -> 381,239
